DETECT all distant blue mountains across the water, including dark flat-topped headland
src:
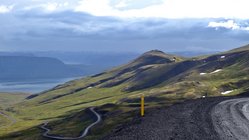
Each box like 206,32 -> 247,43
0,51 -> 220,81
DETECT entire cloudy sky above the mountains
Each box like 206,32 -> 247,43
0,0 -> 249,52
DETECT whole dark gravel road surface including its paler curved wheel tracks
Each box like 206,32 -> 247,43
103,97 -> 249,140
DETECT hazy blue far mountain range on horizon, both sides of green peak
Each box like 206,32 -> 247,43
0,51 -> 217,65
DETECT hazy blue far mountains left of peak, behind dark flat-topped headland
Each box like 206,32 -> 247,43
0,51 -> 140,75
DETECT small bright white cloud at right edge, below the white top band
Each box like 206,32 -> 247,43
208,20 -> 249,31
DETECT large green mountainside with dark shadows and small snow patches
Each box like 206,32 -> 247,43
0,46 -> 249,140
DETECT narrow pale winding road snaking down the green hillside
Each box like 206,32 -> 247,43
41,107 -> 102,140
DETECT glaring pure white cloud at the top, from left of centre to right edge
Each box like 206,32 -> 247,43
75,0 -> 249,19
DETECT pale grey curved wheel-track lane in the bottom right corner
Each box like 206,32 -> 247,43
212,98 -> 249,140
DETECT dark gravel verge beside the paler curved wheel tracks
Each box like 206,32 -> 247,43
104,97 -> 234,140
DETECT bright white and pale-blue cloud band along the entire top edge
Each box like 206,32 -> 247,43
0,0 -> 249,19
